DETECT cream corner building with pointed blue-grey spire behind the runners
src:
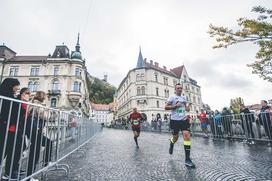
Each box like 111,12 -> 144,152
117,50 -> 202,121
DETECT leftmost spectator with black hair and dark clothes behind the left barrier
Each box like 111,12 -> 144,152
0,78 -> 22,180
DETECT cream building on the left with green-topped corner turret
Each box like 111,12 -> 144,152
0,37 -> 90,116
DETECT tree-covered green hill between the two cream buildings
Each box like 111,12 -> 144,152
87,78 -> 116,104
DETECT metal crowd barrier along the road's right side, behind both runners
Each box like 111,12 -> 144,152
110,112 -> 272,143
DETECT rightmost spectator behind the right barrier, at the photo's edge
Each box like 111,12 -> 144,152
258,100 -> 272,143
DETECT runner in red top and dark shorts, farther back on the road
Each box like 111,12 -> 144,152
129,108 -> 142,148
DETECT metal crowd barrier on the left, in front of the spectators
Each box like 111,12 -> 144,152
0,96 -> 102,181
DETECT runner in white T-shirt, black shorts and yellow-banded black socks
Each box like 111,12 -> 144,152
165,83 -> 195,168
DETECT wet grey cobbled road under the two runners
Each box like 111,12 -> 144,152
48,129 -> 272,181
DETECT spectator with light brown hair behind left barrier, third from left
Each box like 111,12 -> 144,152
27,91 -> 52,180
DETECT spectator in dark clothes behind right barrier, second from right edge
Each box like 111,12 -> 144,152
240,104 -> 255,139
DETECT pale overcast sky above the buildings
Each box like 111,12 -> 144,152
0,0 -> 272,109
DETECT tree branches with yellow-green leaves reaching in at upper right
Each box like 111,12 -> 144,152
208,6 -> 272,82
